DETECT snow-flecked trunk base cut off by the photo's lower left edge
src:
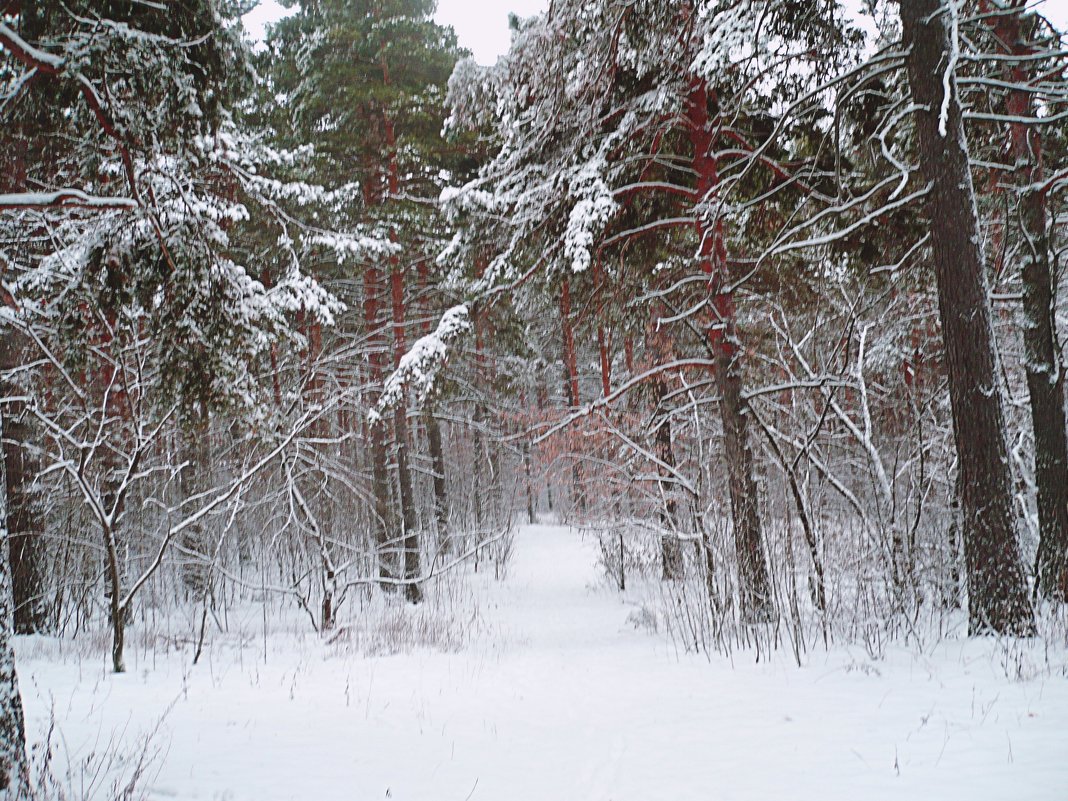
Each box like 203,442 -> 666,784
0,414 -> 26,798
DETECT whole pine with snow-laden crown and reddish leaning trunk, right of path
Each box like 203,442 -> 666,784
437,2 -> 849,621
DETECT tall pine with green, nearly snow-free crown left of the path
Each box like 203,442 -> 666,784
262,0 -> 464,601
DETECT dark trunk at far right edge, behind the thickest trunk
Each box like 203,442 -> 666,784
990,2 -> 1068,600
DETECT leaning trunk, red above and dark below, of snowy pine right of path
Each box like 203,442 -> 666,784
688,80 -> 775,622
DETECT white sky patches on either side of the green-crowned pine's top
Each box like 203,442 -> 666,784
244,0 -> 546,64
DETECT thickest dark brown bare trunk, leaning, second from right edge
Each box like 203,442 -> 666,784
900,0 -> 1035,634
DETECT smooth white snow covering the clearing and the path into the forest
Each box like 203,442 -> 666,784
18,527 -> 1068,801
